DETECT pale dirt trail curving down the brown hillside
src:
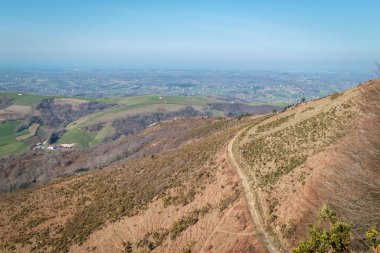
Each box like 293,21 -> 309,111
228,127 -> 280,253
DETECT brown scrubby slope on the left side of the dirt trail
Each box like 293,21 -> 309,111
0,118 -> 265,252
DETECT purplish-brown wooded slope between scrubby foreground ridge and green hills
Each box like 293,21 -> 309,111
0,117 -> 225,192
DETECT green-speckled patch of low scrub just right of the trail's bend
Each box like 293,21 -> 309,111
242,105 -> 354,187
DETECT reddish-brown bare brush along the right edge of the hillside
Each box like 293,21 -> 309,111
324,79 -> 380,248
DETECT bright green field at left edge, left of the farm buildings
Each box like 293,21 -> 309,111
0,120 -> 30,156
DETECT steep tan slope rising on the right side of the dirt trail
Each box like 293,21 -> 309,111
233,79 -> 380,252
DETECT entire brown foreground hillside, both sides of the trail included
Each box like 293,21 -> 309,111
0,80 -> 380,252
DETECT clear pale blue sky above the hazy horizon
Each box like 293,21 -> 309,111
0,0 -> 380,70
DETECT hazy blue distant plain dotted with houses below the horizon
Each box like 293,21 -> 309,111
0,69 -> 374,103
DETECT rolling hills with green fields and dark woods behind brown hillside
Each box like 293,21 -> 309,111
0,92 -> 277,157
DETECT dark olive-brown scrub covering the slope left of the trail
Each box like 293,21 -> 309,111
0,116 -> 255,252
